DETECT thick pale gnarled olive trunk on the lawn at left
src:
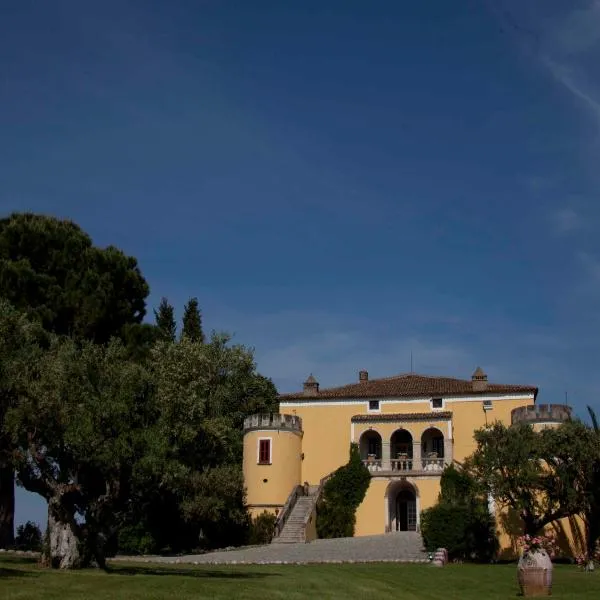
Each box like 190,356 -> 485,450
42,499 -> 86,569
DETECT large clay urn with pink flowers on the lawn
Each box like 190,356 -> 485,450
517,534 -> 556,596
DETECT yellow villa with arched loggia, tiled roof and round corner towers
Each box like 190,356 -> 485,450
244,368 -> 568,541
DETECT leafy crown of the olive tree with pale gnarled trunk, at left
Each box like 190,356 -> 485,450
5,338 -> 153,562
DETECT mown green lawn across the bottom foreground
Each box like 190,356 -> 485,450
0,556 -> 600,600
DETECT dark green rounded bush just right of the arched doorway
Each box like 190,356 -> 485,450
421,465 -> 498,562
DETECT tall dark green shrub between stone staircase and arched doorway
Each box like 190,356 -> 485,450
317,444 -> 371,538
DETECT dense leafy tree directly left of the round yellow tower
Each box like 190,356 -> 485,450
122,334 -> 277,551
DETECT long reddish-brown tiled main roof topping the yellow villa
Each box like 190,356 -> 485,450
279,373 -> 538,402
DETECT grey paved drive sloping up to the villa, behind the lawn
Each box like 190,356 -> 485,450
114,533 -> 429,565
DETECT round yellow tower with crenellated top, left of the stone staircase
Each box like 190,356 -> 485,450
243,413 -> 302,517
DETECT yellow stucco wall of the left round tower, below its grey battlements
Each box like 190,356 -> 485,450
243,429 -> 302,516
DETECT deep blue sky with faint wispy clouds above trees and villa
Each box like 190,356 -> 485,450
0,0 -> 600,522
